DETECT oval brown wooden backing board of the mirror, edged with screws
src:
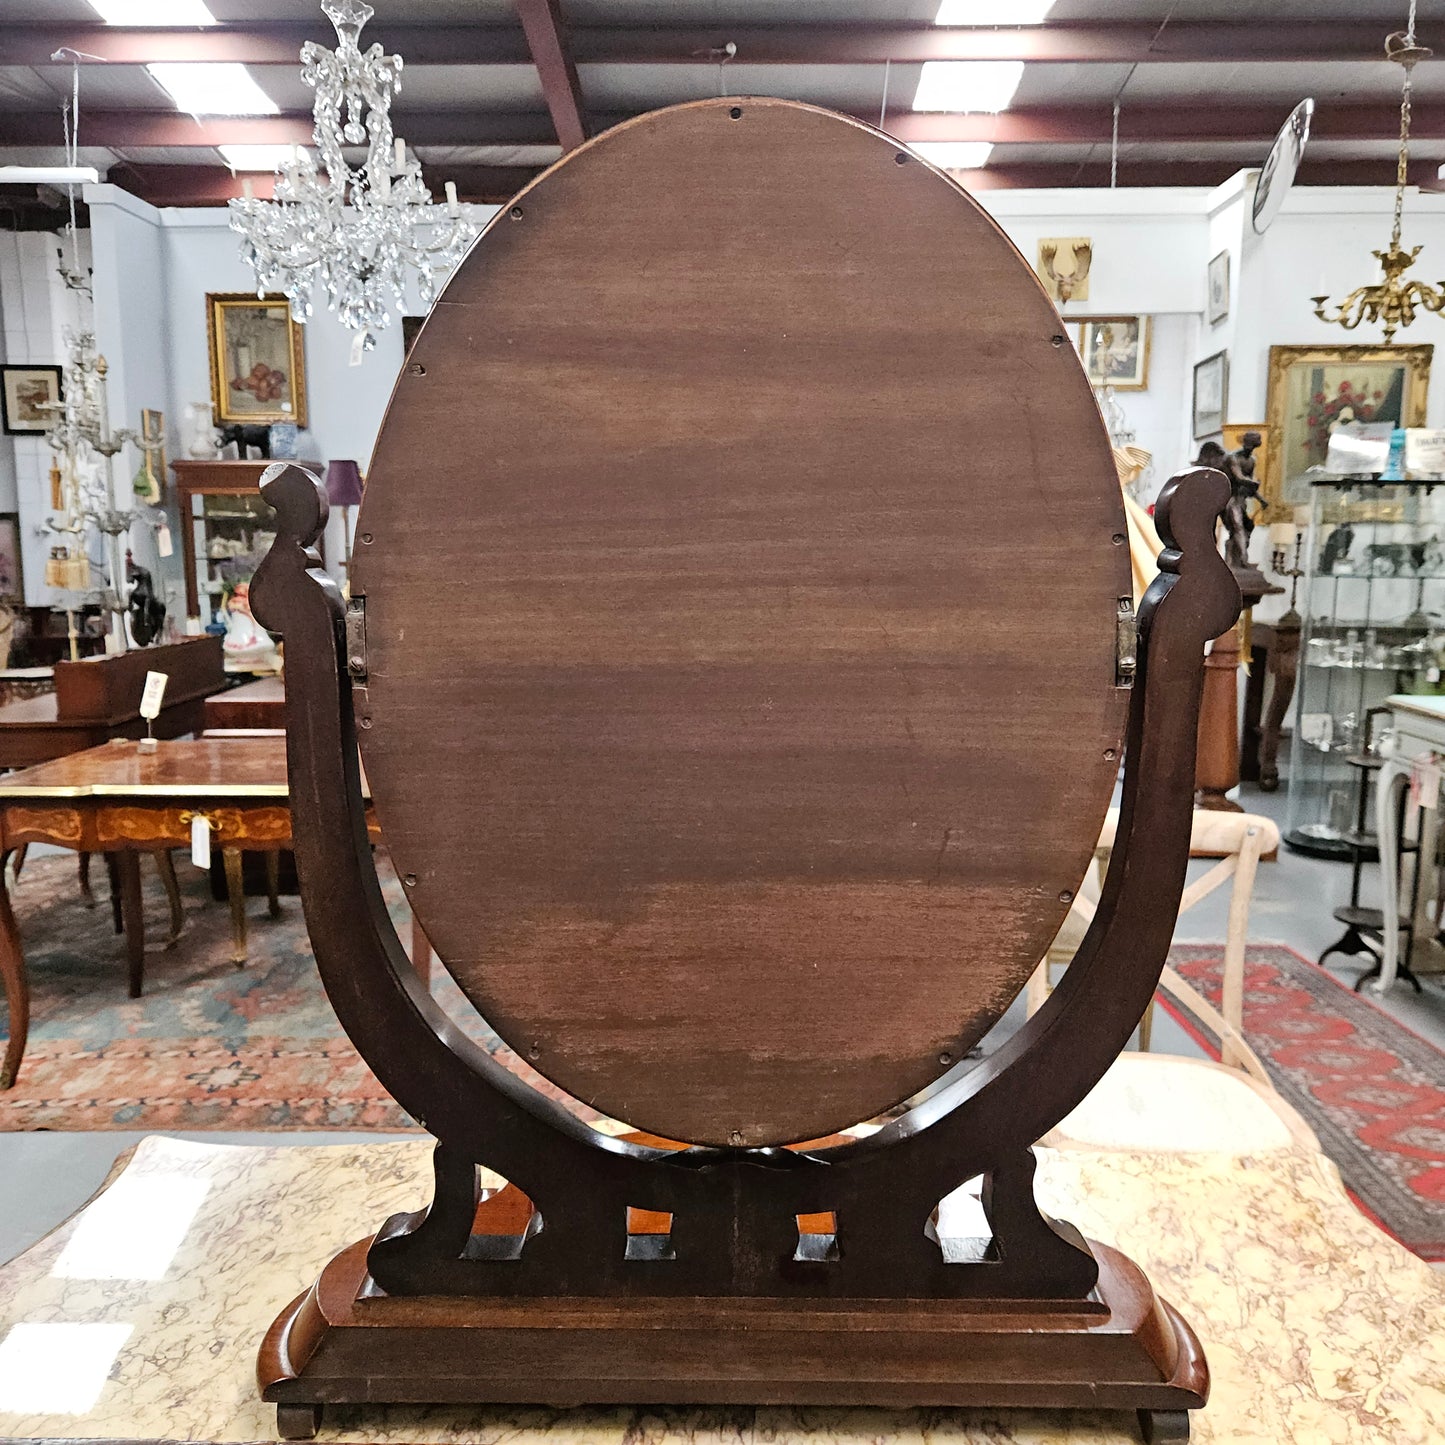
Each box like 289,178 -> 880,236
351,100 -> 1130,1146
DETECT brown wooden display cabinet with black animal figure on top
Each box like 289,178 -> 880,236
171,460 -> 321,623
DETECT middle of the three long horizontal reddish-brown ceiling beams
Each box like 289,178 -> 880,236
0,103 -> 1445,147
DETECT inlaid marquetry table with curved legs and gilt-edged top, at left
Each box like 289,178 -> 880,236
0,736 -> 378,1088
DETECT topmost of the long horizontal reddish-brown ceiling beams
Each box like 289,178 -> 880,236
0,21 -> 1383,66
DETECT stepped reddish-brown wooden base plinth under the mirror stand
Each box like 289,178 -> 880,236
257,1240 -> 1209,1441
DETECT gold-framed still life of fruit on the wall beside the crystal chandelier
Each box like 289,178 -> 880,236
205,292 -> 306,426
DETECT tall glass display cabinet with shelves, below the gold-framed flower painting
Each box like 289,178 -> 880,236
1285,477 -> 1445,861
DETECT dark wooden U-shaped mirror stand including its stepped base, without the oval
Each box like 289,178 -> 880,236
253,464 -> 1240,1439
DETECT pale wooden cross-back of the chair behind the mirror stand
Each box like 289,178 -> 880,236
1027,808 -> 1279,1090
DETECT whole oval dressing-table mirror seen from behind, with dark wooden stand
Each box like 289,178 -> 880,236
242,98 -> 1240,1441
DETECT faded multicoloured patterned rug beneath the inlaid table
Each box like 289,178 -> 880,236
0,853 -> 580,1130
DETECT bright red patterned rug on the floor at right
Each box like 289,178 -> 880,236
1160,944 -> 1445,1260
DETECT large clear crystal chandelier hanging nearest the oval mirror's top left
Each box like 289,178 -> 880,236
230,0 -> 477,351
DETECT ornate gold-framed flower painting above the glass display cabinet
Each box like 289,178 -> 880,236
1260,345 -> 1435,522
